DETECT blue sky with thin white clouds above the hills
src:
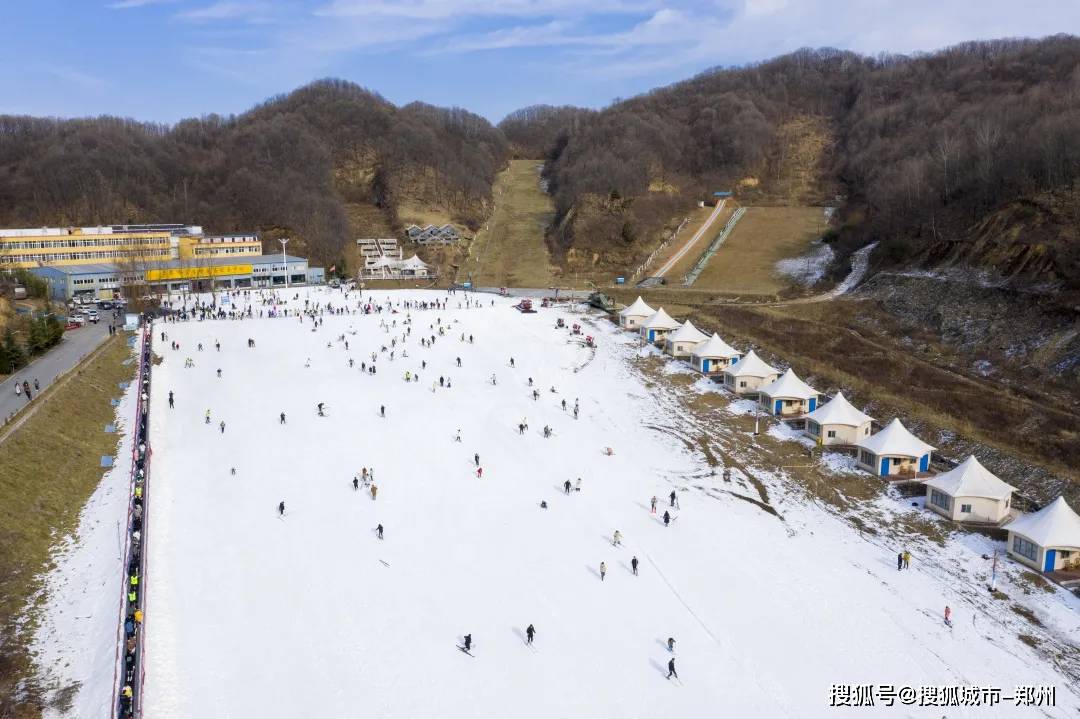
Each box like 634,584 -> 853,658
0,0 -> 1080,122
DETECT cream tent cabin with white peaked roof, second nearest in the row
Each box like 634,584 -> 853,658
924,455 -> 1015,525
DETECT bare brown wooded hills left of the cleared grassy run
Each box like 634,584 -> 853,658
0,80 -> 508,261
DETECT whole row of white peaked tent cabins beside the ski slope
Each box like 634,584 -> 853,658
619,297 -> 1080,571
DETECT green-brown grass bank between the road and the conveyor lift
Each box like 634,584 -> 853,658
0,336 -> 136,719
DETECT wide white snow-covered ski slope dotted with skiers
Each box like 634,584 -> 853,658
145,289 -> 1080,719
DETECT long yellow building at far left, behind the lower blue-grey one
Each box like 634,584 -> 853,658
0,225 -> 187,270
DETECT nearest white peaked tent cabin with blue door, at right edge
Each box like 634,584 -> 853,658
1005,497 -> 1080,572
